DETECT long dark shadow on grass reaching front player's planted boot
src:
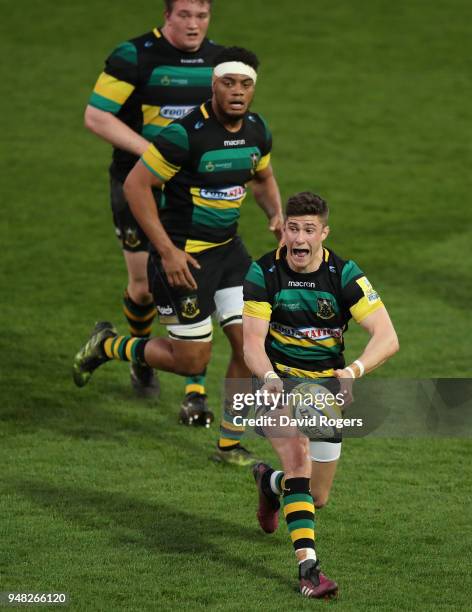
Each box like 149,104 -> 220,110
12,481 -> 293,587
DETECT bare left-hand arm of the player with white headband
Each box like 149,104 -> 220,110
123,159 -> 200,289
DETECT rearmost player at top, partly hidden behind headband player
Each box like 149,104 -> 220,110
85,0 -> 223,404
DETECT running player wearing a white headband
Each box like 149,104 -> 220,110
74,47 -> 283,465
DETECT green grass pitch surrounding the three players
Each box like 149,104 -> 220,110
0,0 -> 472,611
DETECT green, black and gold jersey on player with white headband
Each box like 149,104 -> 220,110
141,101 -> 272,253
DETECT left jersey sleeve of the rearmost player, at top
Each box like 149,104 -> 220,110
89,42 -> 138,115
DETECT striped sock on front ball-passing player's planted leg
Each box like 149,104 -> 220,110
283,478 -> 316,559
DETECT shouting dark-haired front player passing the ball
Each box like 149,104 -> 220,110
243,192 -> 399,598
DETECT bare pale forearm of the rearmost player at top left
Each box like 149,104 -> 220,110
84,104 -> 149,156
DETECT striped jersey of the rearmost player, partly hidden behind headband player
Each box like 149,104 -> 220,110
89,28 -> 223,181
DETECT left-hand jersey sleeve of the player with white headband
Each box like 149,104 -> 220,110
141,123 -> 189,183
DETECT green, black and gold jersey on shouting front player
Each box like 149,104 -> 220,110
244,247 -> 383,378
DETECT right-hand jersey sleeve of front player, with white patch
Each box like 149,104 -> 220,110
341,261 -> 383,323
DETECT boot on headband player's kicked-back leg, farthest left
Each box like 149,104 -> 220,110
72,321 -> 117,387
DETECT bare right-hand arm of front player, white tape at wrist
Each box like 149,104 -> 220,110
334,306 -> 400,378
